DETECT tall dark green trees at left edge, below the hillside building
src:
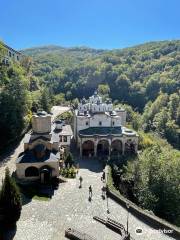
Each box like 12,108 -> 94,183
0,64 -> 32,149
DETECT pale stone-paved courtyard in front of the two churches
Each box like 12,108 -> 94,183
3,159 -> 175,240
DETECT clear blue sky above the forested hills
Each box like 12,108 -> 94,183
0,0 -> 180,49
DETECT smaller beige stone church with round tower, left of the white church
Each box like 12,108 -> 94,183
16,111 -> 72,183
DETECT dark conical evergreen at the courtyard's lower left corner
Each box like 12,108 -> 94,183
0,169 -> 22,226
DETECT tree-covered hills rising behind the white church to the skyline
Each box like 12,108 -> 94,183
23,41 -> 180,148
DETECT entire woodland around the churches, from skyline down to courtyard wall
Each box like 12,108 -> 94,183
0,41 -> 180,226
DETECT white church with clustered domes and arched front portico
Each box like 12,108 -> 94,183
74,92 -> 138,157
